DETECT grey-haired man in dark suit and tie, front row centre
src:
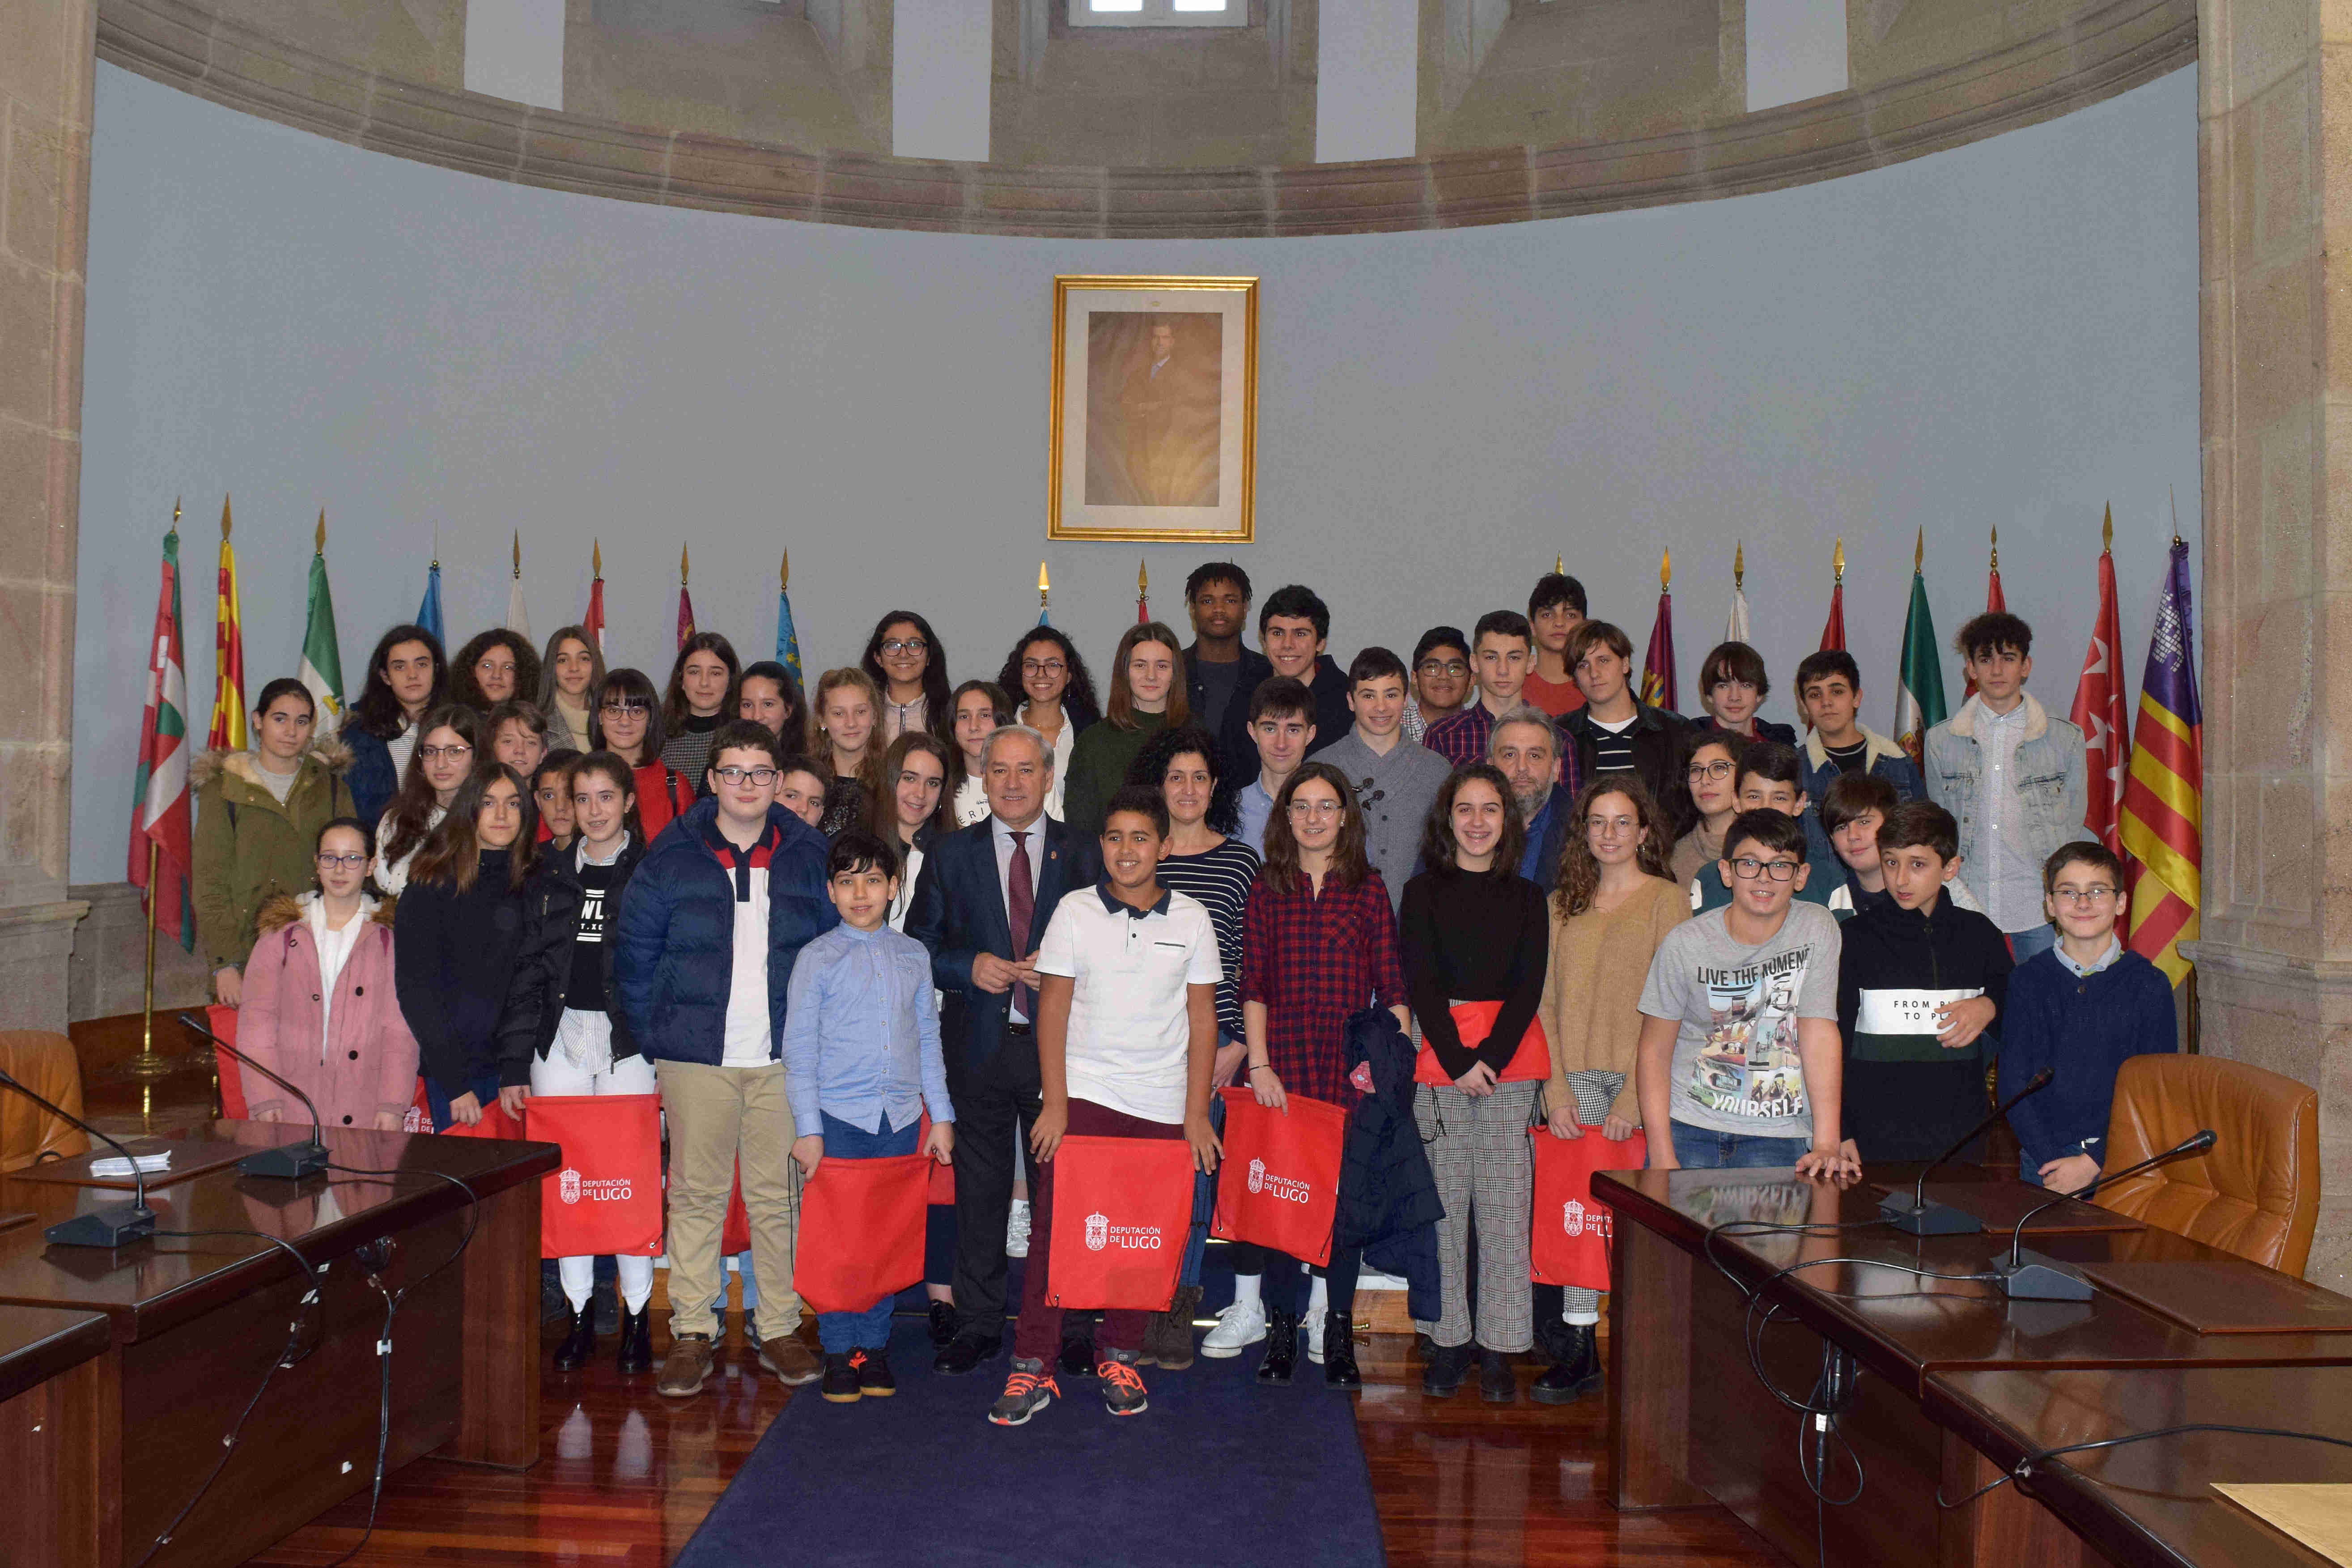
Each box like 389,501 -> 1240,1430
905,724 -> 1103,1375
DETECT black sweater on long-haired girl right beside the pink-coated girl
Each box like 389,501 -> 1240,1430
393,849 -> 531,1098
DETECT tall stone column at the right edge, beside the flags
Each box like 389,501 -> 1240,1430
2197,0 -> 2352,1288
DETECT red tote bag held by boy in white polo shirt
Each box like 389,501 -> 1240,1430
1044,1138 -> 1193,1312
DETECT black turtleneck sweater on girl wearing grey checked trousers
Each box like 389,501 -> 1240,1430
1400,867 -> 1550,1079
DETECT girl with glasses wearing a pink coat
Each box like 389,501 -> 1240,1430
238,816 -> 416,1133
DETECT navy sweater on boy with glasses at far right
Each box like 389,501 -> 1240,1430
1995,952 -> 2180,1166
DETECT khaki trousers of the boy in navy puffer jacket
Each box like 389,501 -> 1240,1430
654,1062 -> 802,1340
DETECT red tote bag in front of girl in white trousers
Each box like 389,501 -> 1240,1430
522,1096 -> 661,1258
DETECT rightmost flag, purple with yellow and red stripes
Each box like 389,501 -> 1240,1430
2122,538 -> 2204,985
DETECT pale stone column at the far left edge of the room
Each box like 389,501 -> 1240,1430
0,0 -> 99,1030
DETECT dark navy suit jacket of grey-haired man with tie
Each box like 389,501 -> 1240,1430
905,816 -> 1103,1070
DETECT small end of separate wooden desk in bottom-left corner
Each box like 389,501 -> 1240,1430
0,1307 -> 113,1568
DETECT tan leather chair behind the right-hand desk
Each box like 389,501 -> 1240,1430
2096,1055 -> 2319,1274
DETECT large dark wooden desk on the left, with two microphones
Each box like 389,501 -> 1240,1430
0,1122 -> 557,1566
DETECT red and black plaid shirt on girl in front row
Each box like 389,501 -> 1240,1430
1242,872 -> 1406,1107
